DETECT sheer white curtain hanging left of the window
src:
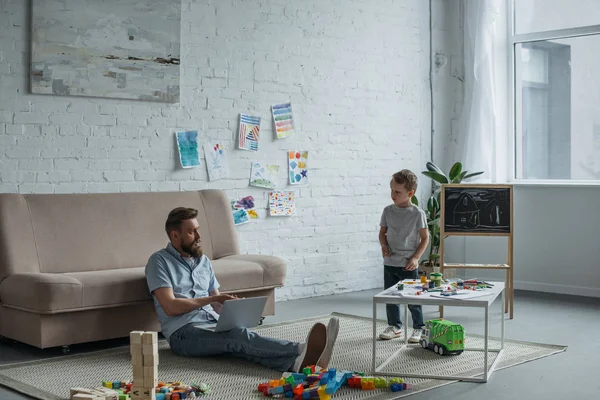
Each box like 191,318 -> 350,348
455,0 -> 512,183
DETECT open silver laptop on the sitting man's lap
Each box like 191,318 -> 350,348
207,296 -> 267,332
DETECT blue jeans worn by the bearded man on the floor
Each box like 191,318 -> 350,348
169,324 -> 300,372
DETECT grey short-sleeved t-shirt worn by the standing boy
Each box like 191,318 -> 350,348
380,204 -> 427,267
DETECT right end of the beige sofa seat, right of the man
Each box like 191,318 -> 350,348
212,254 -> 286,291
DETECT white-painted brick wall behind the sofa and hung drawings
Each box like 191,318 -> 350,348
0,0 -> 430,299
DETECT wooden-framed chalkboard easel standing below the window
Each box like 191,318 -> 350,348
440,184 -> 514,319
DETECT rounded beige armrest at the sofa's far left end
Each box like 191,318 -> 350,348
0,273 -> 83,313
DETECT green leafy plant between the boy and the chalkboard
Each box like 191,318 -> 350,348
412,162 -> 483,273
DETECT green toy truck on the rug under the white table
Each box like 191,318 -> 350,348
420,318 -> 465,356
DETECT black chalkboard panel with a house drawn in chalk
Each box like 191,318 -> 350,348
444,188 -> 510,233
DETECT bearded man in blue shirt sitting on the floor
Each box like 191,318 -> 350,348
146,207 -> 339,372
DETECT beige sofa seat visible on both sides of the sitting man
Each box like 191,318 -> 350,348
0,254 -> 286,314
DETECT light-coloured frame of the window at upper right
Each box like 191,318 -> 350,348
507,0 -> 600,187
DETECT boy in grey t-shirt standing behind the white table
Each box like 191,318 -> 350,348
379,169 -> 429,343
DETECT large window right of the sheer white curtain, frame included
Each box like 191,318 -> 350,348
511,0 -> 600,182
